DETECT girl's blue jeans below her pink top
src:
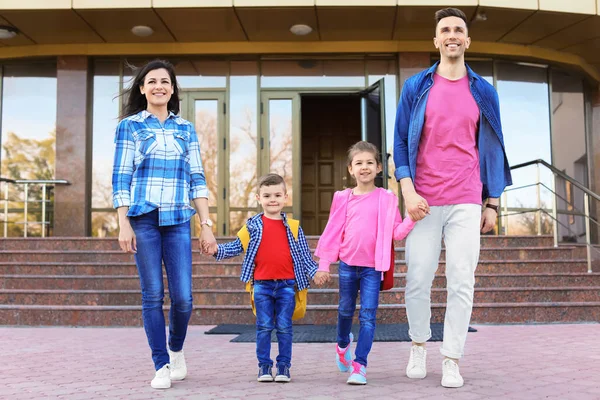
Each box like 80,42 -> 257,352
337,261 -> 381,367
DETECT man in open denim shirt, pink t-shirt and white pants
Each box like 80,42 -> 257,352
394,8 -> 512,387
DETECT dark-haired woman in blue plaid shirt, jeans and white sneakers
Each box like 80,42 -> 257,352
112,60 -> 216,389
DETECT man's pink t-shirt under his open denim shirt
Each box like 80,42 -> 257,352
414,74 -> 482,206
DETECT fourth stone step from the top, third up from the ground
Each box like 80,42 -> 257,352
0,272 -> 600,290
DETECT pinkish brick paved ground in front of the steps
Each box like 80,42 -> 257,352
0,324 -> 600,400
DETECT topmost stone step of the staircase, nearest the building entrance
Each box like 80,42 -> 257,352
0,235 -> 553,251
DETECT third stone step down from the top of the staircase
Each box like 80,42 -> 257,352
0,259 -> 587,276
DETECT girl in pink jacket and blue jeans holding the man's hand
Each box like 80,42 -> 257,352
315,141 -> 414,385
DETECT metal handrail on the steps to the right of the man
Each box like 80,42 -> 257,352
498,159 -> 600,273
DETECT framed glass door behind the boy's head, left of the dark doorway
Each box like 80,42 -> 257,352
258,91 -> 301,219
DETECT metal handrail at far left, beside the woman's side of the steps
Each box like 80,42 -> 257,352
0,177 -> 70,237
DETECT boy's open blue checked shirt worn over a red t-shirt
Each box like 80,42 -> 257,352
215,213 -> 317,290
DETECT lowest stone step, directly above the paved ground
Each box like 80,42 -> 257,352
0,302 -> 600,326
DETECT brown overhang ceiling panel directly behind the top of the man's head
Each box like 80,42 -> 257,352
394,6 -> 476,40
